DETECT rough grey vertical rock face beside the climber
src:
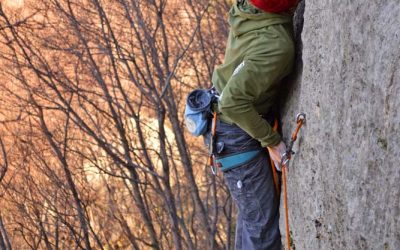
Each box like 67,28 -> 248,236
281,0 -> 400,250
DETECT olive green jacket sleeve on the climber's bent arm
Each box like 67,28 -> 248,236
219,41 -> 294,147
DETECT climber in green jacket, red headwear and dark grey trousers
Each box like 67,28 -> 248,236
205,0 -> 296,250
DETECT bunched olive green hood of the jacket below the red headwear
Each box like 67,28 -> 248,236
229,4 -> 292,36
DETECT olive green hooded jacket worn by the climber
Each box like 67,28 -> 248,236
212,0 -> 294,147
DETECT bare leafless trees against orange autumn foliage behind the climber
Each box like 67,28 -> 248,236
0,0 -> 241,249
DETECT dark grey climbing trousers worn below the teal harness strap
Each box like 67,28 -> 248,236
206,122 -> 282,250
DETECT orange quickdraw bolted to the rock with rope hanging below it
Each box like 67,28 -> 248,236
280,113 -> 306,250
